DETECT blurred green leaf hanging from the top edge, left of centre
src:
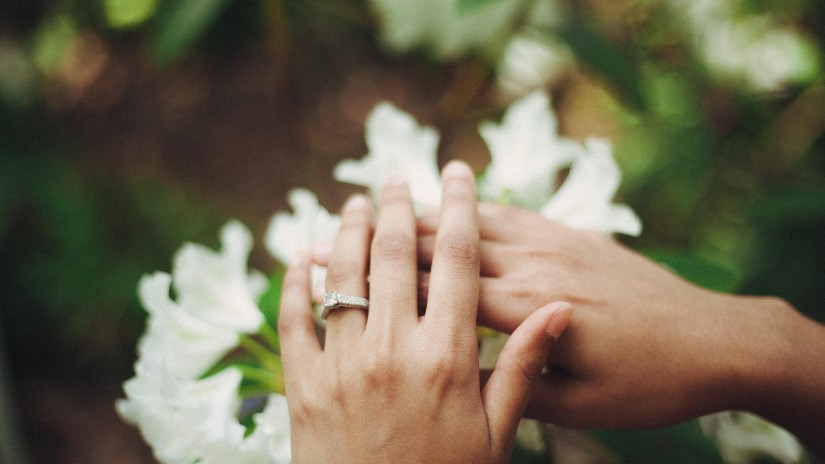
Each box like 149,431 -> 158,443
154,0 -> 231,66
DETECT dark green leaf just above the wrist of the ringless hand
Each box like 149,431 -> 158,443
644,250 -> 739,292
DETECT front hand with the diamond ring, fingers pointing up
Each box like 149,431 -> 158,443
279,163 -> 571,463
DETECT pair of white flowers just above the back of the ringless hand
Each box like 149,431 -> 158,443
479,92 -> 642,235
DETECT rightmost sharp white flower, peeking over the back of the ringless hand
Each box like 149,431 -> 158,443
541,140 -> 642,235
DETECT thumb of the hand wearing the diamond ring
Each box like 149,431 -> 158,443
481,302 -> 573,455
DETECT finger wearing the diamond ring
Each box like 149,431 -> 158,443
326,194 -> 372,346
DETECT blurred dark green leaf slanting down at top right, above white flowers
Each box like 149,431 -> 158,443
553,17 -> 647,109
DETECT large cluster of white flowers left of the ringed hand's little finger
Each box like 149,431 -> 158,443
116,221 -> 289,464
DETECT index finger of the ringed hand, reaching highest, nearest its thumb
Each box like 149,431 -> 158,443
426,161 -> 479,334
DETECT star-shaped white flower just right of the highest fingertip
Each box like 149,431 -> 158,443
478,92 -> 581,210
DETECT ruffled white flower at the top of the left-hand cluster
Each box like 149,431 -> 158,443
138,221 -> 267,379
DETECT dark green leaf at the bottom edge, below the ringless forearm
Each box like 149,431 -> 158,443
591,420 -> 722,464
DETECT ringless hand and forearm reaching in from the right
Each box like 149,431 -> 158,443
419,204 -> 825,454
